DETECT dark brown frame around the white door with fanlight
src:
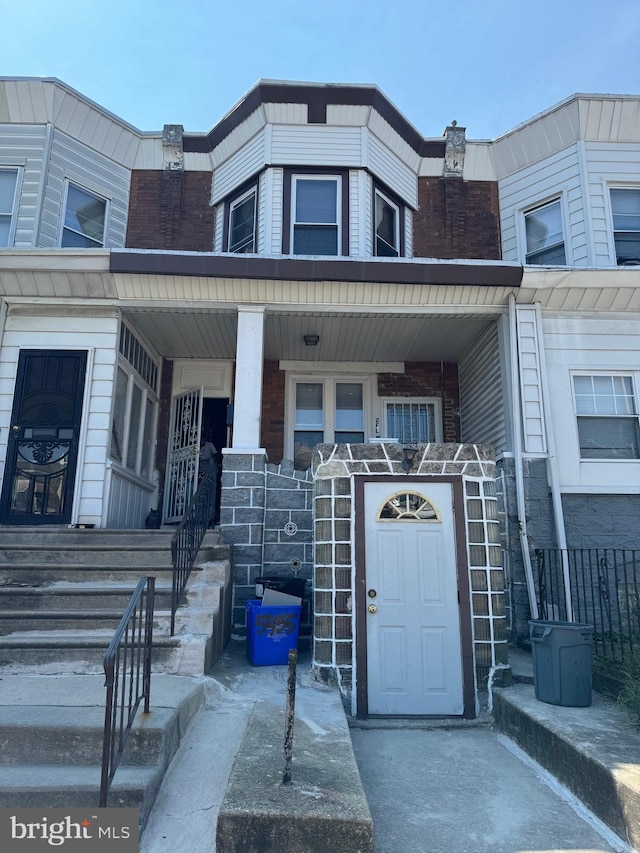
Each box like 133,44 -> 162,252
354,475 -> 476,720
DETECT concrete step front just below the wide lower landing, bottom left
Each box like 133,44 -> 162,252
0,704 -> 180,766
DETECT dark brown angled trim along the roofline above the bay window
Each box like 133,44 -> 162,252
183,83 -> 445,158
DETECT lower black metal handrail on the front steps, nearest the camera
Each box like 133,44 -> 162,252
100,577 -> 156,808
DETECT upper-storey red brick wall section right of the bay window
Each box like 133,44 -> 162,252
413,177 -> 501,260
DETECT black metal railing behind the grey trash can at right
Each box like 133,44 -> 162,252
535,548 -> 640,661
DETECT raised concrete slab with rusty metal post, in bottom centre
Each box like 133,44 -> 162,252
215,690 -> 373,853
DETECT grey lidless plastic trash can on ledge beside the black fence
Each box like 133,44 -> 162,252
529,619 -> 593,708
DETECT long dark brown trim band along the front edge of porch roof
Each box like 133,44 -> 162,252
109,249 -> 523,287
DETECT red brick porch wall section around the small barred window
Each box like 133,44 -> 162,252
378,361 -> 460,443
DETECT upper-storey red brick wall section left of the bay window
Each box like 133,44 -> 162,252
126,170 -> 215,252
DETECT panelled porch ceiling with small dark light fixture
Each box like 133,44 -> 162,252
126,307 -> 495,362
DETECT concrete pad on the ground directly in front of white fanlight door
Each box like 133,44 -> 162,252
351,726 -> 628,853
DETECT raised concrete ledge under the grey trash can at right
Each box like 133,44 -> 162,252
493,684 -> 640,849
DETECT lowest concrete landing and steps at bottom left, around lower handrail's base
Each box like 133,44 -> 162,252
0,674 -> 205,827
